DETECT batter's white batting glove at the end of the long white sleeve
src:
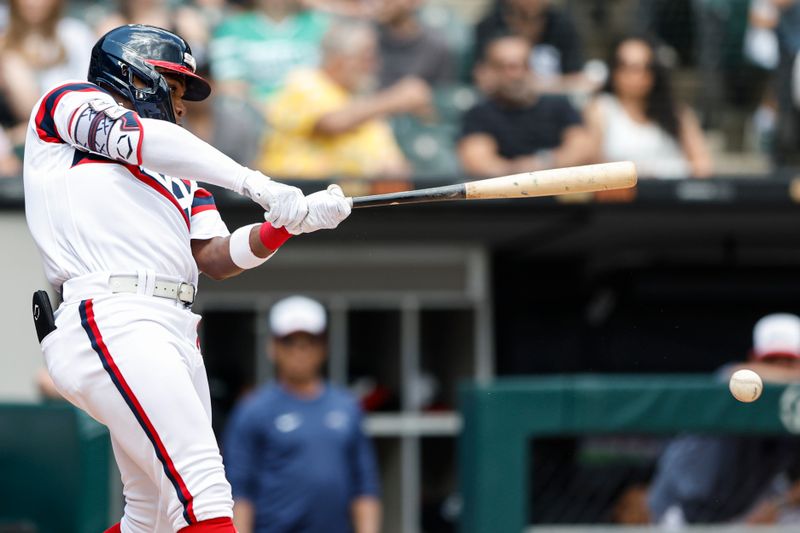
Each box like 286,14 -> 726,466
242,171 -> 308,228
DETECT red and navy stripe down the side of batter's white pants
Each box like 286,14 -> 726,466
79,300 -> 197,525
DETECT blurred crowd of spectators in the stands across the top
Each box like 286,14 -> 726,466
0,0 -> 800,179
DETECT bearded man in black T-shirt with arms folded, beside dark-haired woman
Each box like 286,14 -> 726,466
458,36 -> 592,180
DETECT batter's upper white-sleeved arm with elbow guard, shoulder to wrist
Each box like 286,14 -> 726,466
31,82 -> 253,194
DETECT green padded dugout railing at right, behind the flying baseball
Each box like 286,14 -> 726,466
459,375 -> 800,533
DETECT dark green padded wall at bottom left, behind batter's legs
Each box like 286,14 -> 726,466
0,402 -> 111,533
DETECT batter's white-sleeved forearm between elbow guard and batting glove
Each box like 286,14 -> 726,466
140,118 -> 250,194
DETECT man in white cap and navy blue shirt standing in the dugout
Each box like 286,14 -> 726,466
223,296 -> 381,533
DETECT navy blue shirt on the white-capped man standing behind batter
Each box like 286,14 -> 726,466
223,384 -> 379,533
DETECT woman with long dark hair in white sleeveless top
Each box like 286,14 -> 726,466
585,36 -> 713,179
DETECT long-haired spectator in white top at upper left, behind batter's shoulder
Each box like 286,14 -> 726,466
0,0 -> 95,145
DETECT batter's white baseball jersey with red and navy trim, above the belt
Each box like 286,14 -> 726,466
24,82 -> 229,288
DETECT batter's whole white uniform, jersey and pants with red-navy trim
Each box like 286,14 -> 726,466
24,82 -> 241,533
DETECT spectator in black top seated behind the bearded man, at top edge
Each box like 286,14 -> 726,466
475,0 -> 596,92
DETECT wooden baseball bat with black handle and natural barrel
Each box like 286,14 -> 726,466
350,161 -> 637,208
